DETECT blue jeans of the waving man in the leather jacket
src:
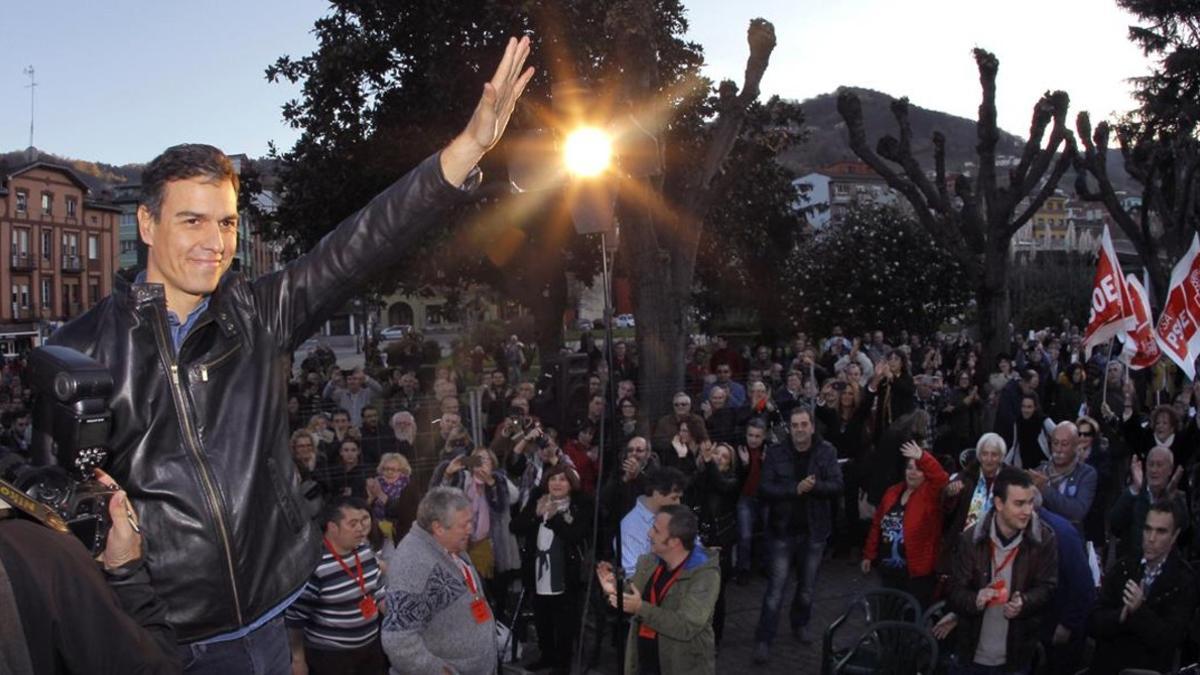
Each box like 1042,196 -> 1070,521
179,614 -> 292,675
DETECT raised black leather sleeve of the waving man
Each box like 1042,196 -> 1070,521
253,154 -> 479,352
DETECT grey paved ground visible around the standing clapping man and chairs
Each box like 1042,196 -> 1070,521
505,558 -> 878,675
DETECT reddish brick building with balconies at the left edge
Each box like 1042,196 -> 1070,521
0,161 -> 120,353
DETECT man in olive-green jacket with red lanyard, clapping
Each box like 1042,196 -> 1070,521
598,504 -> 721,675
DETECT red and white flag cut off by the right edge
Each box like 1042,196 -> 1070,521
1154,235 -> 1200,380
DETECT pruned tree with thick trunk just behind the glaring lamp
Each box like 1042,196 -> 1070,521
608,0 -> 775,419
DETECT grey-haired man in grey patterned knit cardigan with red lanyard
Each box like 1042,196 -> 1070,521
383,486 -> 497,675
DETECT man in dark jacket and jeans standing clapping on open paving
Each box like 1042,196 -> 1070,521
754,407 -> 842,664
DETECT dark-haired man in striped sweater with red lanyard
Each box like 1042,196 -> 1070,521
284,497 -> 386,675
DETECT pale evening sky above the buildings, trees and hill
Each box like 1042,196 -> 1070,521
0,0 -> 1148,165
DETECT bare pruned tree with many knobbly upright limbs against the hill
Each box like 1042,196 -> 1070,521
838,49 -> 1076,363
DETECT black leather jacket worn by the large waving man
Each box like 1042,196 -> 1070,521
50,155 -> 478,643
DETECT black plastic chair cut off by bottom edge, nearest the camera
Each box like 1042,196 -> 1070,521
832,621 -> 937,675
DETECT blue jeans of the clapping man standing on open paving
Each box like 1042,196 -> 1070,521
755,534 -> 828,644
